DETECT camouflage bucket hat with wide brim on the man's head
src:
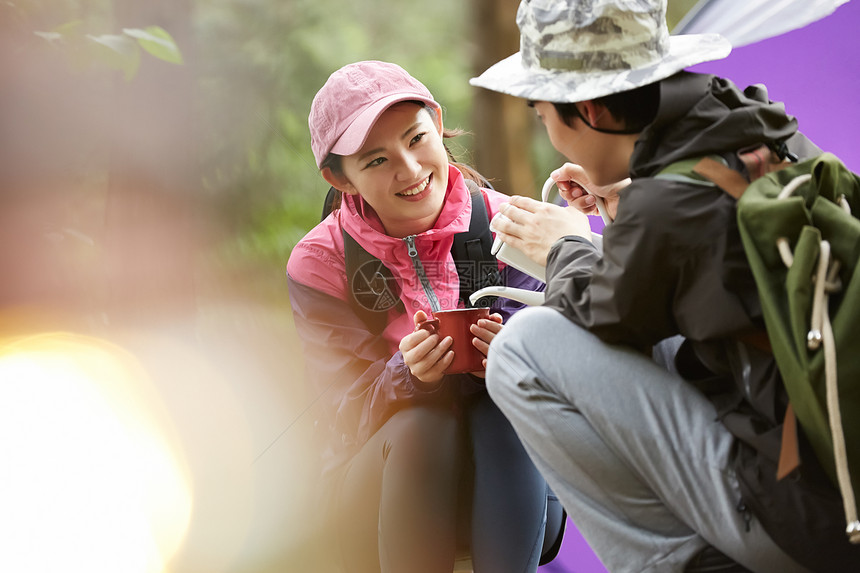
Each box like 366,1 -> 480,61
469,0 -> 731,103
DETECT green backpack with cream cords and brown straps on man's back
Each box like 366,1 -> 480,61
658,148 -> 860,543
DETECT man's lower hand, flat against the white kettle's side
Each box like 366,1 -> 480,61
492,195 -> 591,265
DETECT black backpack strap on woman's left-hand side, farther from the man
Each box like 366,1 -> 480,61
343,230 -> 406,335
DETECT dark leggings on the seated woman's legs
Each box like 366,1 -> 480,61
335,393 -> 563,573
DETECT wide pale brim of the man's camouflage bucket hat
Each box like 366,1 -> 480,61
469,34 -> 732,103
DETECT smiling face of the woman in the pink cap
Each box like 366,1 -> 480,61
323,102 -> 448,237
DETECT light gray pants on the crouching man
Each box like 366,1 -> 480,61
487,307 -> 805,573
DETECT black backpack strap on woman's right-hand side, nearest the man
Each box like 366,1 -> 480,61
451,183 -> 502,308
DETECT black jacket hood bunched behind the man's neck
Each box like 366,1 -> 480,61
630,72 -> 797,178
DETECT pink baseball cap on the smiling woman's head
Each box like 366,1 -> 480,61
308,61 -> 440,167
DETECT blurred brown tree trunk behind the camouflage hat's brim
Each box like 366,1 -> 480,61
472,0 -> 534,195
